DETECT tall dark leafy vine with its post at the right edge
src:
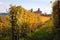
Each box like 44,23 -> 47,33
53,0 -> 60,39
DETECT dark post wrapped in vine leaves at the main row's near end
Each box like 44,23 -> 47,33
10,6 -> 19,40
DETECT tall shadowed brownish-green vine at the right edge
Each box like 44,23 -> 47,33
53,1 -> 60,31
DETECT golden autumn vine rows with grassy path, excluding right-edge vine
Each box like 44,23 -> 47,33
0,6 -> 56,40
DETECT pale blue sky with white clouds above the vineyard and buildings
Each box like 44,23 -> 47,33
0,0 -> 54,14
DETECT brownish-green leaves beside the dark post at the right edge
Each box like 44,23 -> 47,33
53,1 -> 59,27
